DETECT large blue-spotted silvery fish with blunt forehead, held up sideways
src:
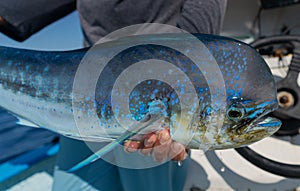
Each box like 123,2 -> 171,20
0,34 -> 281,169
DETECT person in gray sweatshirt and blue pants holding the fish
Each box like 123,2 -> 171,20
0,0 -> 226,191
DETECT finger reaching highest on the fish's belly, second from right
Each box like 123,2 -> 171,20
152,129 -> 172,162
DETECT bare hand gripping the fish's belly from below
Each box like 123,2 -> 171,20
124,127 -> 187,162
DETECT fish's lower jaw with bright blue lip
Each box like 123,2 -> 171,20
246,116 -> 282,135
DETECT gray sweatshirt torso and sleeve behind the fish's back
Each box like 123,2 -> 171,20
77,0 -> 226,45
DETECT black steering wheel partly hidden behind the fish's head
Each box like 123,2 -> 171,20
235,35 -> 300,178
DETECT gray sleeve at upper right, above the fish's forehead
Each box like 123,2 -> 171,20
177,0 -> 227,34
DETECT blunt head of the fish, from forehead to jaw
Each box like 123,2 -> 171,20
184,35 -> 281,149
